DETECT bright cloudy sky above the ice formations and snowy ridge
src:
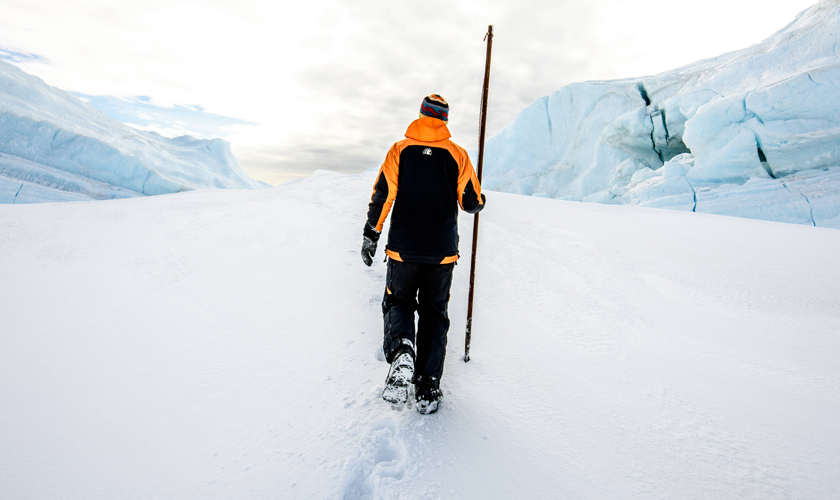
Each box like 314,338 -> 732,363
0,0 -> 814,184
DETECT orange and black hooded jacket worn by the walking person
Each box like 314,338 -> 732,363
365,117 -> 484,264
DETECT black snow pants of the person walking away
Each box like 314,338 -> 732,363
382,259 -> 455,380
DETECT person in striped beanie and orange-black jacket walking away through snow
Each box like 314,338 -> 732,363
362,94 -> 485,414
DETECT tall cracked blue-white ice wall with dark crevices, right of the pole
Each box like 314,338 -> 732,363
485,0 -> 840,228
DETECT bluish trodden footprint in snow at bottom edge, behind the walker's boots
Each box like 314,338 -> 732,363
341,417 -> 406,500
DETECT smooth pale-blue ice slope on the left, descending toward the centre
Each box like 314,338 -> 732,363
0,61 -> 269,203
